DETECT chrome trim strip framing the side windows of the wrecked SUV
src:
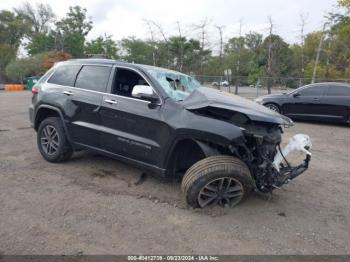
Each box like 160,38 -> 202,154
44,63 -> 163,106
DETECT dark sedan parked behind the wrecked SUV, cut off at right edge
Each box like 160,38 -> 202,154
255,83 -> 350,123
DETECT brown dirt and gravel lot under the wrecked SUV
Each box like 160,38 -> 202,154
0,92 -> 350,254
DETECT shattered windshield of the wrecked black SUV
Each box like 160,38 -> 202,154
147,68 -> 201,101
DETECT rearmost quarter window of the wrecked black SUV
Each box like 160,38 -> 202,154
47,65 -> 81,86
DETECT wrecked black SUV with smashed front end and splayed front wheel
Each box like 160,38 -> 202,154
29,59 -> 310,207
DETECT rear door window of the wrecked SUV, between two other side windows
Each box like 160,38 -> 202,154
75,65 -> 112,92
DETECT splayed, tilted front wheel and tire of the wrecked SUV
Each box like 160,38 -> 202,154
181,155 -> 253,208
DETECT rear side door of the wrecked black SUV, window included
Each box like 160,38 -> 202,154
65,65 -> 112,147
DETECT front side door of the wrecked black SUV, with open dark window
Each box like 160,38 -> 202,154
100,68 -> 169,165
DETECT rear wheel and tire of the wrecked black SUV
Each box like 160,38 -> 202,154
37,117 -> 73,163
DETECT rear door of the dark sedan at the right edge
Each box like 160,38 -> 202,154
321,84 -> 350,121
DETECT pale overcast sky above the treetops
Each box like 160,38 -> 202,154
0,0 -> 336,49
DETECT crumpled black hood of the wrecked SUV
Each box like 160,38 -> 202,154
183,87 -> 293,125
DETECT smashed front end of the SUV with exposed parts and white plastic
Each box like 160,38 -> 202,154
231,123 -> 311,193
